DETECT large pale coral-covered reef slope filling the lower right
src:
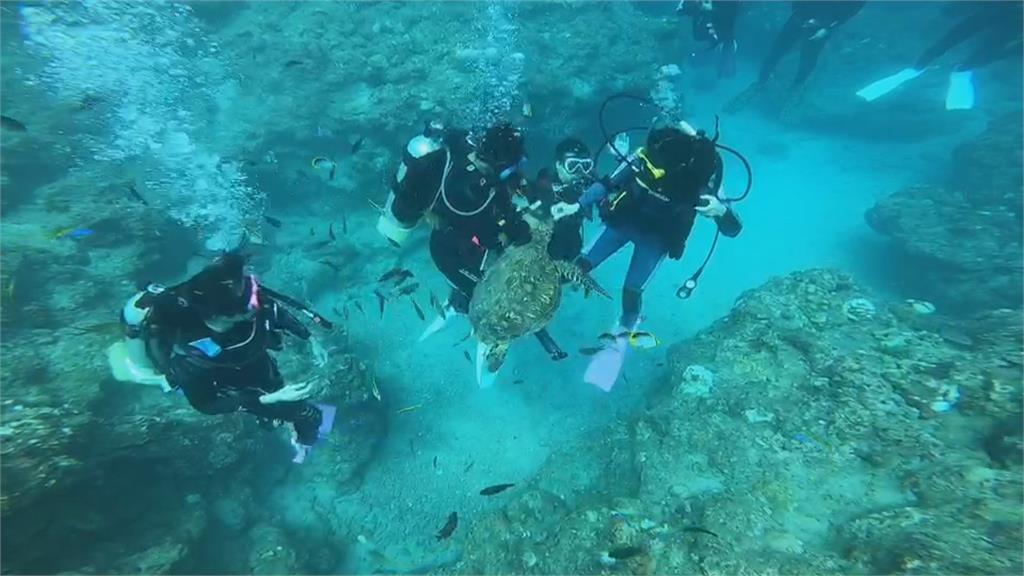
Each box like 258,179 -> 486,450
453,271 -> 1022,574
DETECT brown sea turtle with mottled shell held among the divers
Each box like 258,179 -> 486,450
469,222 -> 610,385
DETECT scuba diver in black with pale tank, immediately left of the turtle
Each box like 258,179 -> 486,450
377,123 -> 567,387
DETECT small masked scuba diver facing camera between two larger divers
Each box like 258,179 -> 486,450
519,137 -> 594,260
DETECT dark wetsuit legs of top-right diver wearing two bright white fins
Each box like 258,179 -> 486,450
914,2 -> 1024,71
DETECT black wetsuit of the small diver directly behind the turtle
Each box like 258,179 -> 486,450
523,168 -> 591,260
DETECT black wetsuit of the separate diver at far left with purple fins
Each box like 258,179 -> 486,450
146,292 -> 322,446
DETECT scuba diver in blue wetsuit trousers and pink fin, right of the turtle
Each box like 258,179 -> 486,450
551,122 -> 745,392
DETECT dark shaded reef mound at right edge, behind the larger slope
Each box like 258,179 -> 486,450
866,114 -> 1024,311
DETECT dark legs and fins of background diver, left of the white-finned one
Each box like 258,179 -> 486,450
725,0 -> 866,112
